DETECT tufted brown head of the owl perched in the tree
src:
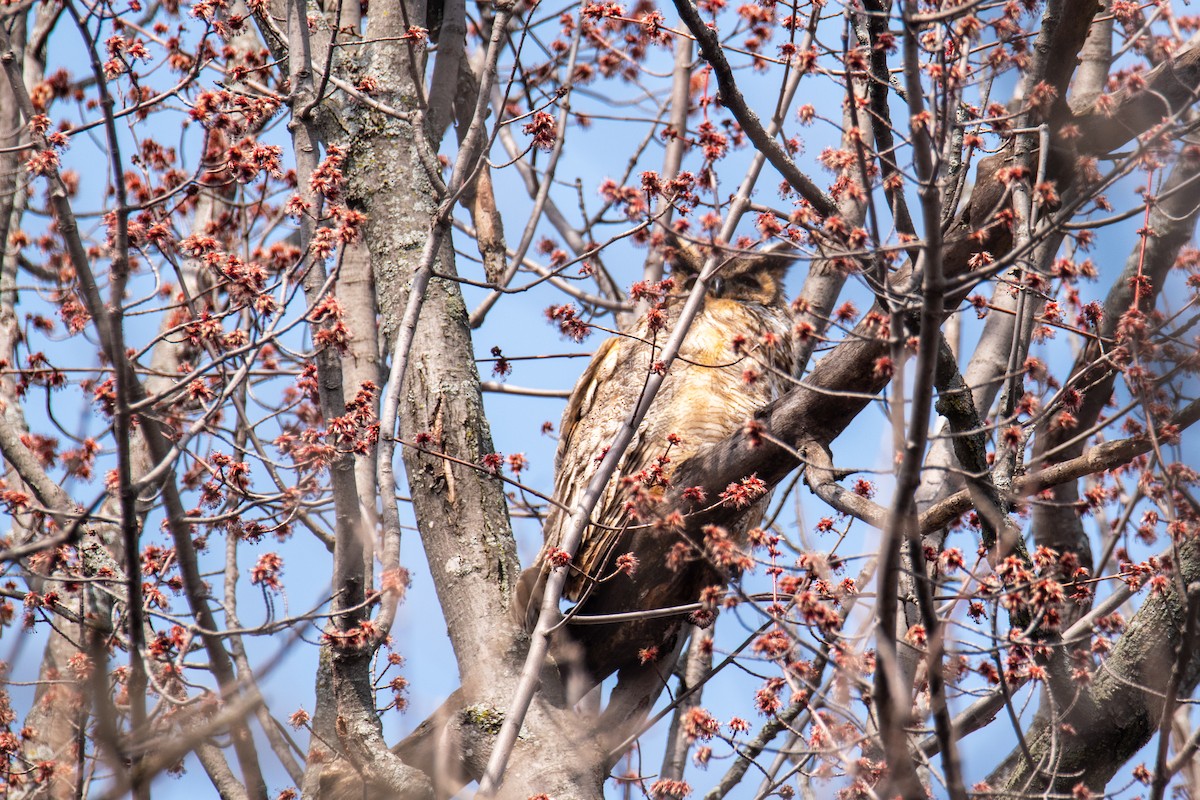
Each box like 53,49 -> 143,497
671,240 -> 794,306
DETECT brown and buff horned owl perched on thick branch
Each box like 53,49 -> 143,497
515,245 -> 792,681
